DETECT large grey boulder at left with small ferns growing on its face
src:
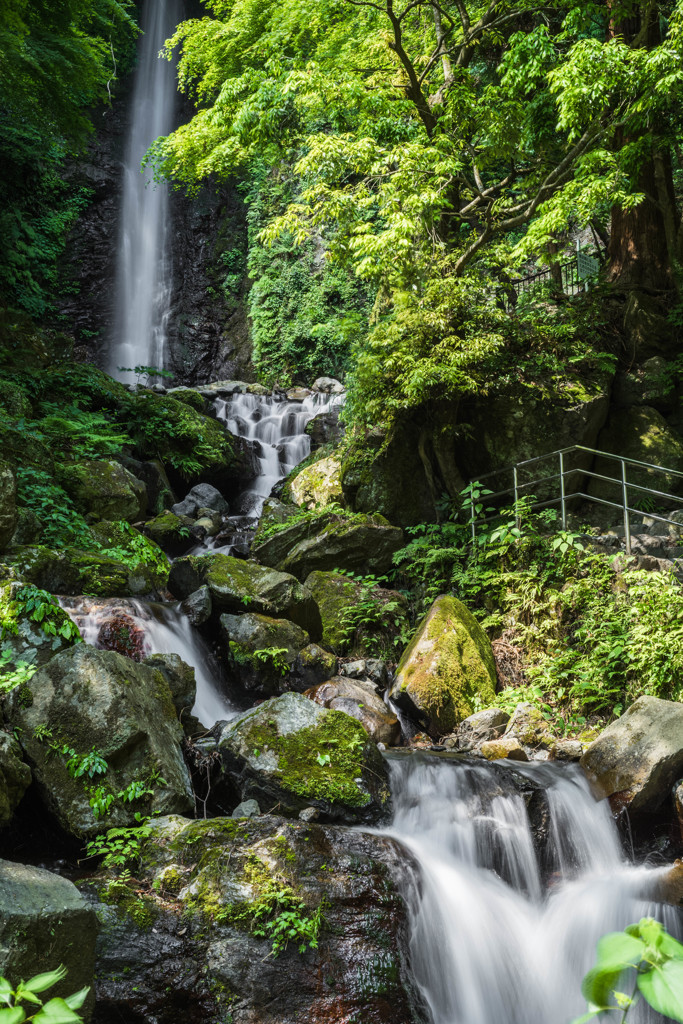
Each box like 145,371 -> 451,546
6,644 -> 194,838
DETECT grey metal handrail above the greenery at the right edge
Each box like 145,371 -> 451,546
470,444 -> 683,555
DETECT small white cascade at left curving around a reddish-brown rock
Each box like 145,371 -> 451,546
59,597 -> 238,727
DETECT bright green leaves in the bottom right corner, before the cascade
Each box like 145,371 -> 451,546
572,918 -> 683,1024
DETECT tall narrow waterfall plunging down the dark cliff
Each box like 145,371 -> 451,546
109,0 -> 181,379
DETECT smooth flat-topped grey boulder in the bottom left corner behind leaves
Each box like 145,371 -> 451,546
0,860 -> 98,1020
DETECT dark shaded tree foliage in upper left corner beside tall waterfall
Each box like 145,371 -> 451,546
0,0 -> 136,315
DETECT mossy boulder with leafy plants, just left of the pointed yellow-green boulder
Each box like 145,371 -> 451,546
305,571 -> 409,659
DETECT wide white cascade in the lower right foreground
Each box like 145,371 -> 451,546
390,755 -> 680,1024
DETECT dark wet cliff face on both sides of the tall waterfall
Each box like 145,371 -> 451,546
57,62 -> 254,384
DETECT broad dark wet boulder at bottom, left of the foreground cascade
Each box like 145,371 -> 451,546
82,815 -> 425,1024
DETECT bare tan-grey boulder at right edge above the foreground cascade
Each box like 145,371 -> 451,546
581,696 -> 683,814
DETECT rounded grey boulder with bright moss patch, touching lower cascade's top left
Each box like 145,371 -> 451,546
218,693 -> 390,822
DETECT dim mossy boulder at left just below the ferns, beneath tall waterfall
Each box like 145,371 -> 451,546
60,459 -> 147,522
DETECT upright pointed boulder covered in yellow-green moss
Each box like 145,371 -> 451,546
391,595 -> 496,737
